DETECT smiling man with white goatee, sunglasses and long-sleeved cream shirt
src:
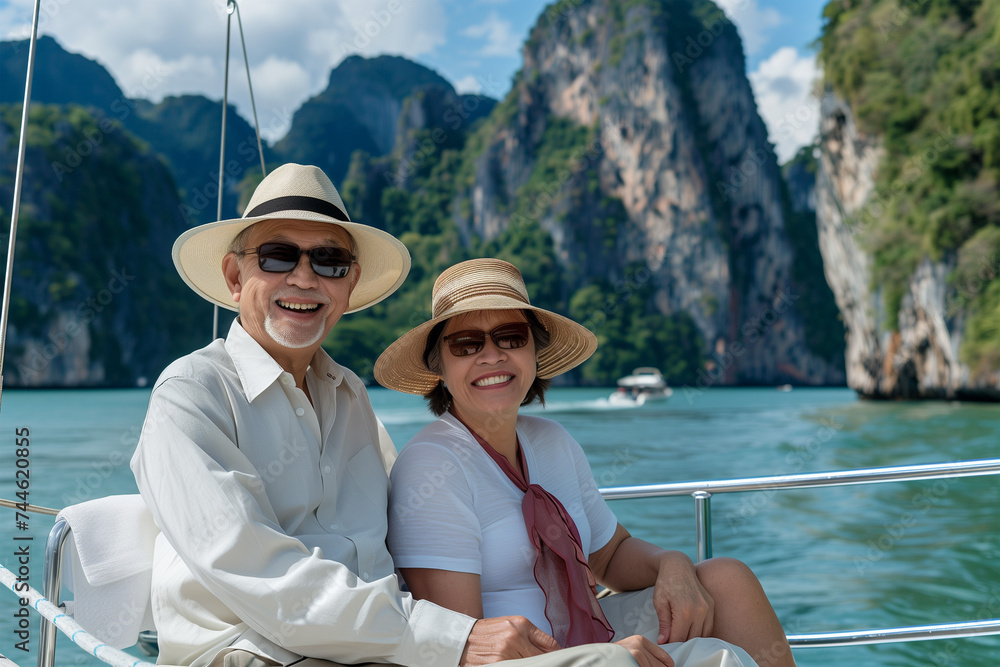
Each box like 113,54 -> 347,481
132,164 -> 656,667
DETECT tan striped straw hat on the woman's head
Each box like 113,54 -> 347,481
375,259 -> 597,395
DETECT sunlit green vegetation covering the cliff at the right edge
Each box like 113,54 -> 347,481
820,0 -> 1000,368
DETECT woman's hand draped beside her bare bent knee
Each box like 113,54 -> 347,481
653,551 -> 715,644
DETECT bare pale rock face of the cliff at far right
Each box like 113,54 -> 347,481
816,93 -> 1000,400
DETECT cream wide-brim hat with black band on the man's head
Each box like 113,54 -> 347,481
173,163 -> 410,313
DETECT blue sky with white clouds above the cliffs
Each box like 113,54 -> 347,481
0,0 -> 826,160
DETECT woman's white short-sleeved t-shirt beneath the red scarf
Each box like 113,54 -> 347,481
387,414 -> 618,632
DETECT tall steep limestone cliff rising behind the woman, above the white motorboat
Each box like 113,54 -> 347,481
458,0 -> 843,384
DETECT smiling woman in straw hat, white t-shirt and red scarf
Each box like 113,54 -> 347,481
375,259 -> 794,666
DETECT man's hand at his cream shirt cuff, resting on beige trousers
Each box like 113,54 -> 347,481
459,616 -> 560,666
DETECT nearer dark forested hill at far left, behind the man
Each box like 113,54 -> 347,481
0,105 -> 211,386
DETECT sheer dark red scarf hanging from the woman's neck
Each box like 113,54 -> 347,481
466,426 -> 615,648
